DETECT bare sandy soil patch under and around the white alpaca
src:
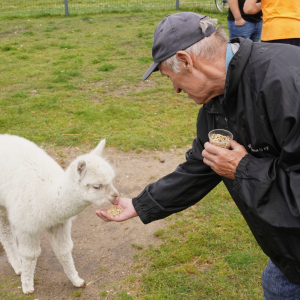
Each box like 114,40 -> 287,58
0,148 -> 187,300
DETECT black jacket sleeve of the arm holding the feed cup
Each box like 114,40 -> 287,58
234,58 -> 300,227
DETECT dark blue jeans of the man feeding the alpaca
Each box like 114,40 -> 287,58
261,259 -> 300,300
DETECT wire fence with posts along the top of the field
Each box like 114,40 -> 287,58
0,0 -> 217,17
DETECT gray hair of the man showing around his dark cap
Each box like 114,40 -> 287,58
162,17 -> 228,74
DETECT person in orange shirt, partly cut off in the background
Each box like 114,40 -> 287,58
244,0 -> 300,46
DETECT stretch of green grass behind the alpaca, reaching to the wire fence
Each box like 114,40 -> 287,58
0,11 -> 225,151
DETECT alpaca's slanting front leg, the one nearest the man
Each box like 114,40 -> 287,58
48,221 -> 84,287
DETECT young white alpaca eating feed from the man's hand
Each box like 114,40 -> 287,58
0,134 -> 118,294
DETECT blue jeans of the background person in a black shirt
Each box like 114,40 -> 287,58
227,20 -> 262,42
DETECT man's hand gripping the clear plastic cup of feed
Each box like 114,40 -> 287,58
202,140 -> 248,179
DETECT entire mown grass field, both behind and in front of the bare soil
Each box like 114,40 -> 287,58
0,11 -> 267,300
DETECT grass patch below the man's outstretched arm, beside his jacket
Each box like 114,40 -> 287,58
112,184 -> 267,300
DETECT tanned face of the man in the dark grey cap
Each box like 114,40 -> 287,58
159,53 -> 222,104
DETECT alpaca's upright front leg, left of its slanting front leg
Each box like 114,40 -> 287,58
16,230 -> 41,294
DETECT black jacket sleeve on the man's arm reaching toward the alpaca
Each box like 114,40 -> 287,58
132,137 -> 221,224
